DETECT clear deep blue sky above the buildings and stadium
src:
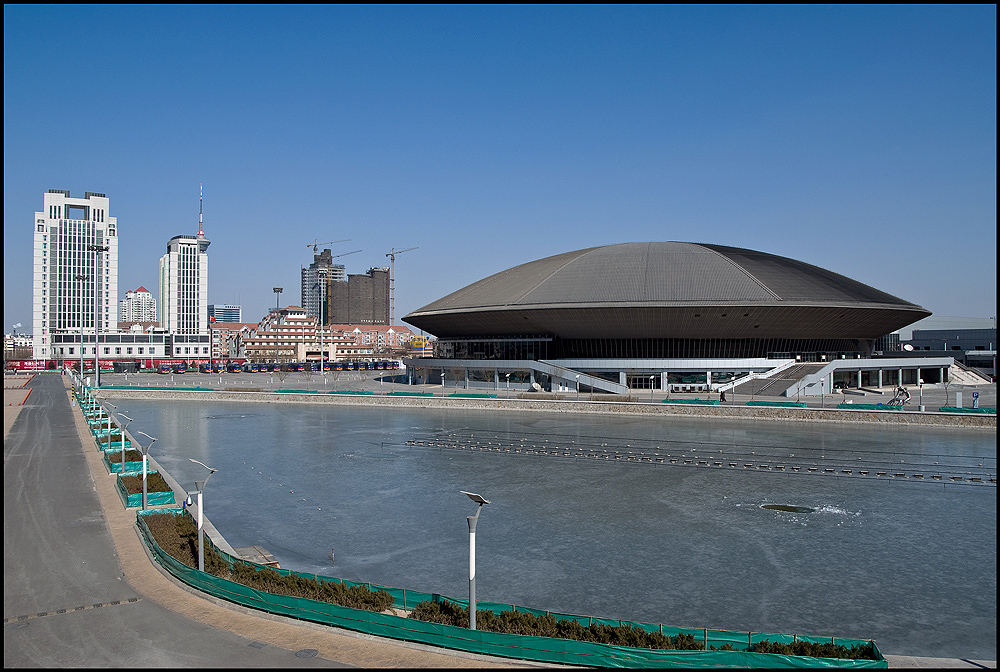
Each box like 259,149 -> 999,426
4,5 -> 997,331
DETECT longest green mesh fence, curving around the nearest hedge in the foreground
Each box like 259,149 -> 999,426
138,509 -> 888,669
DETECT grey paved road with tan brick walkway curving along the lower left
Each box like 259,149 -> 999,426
4,374 -> 524,668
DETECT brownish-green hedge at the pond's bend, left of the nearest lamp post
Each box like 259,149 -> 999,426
145,512 -> 393,611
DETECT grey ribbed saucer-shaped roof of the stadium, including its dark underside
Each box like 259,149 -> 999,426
403,242 -> 930,338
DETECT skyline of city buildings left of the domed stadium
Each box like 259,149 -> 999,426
18,189 -> 412,368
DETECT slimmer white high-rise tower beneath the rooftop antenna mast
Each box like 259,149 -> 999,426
160,230 -> 211,334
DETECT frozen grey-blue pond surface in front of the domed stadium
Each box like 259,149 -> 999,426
109,400 -> 996,660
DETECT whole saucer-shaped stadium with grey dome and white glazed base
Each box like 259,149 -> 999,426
403,242 -> 947,394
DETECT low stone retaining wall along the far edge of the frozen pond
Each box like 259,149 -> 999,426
97,388 -> 997,431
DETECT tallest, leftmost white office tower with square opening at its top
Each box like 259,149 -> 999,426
32,189 -> 118,359
